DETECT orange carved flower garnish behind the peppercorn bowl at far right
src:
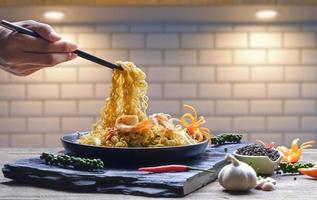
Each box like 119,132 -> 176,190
277,138 -> 315,163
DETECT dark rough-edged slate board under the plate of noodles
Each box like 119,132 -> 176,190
2,144 -> 245,197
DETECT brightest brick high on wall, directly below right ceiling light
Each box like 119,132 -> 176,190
250,33 -> 282,48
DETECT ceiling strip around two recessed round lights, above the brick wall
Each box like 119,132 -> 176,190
0,6 -> 317,23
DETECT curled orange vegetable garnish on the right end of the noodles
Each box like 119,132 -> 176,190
180,104 -> 211,142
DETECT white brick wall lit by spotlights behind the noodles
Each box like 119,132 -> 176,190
0,23 -> 317,147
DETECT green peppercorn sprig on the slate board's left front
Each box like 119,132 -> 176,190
41,153 -> 104,171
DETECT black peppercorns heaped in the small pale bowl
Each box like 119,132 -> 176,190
237,144 -> 280,161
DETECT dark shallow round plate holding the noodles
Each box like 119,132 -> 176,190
61,132 -> 208,165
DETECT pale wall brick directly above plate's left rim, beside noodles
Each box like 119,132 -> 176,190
62,117 -> 94,133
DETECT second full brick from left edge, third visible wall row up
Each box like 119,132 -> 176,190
44,101 -> 77,116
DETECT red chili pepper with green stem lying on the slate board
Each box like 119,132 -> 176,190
139,165 -> 214,173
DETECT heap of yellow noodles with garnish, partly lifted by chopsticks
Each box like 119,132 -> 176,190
78,61 -> 211,147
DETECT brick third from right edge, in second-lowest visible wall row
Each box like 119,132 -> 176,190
233,117 -> 265,132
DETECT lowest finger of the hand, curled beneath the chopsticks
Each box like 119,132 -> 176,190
20,53 -> 77,67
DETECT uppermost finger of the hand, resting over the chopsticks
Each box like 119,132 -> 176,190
15,20 -> 62,42
